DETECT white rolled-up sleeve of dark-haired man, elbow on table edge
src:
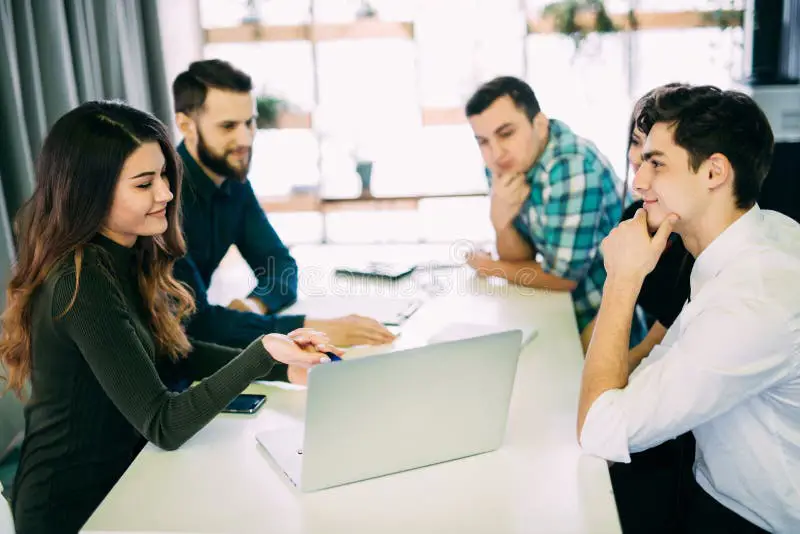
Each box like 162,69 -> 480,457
580,301 -> 798,462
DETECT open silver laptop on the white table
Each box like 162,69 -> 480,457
256,330 -> 522,491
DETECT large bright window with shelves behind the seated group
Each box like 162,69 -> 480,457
201,0 -> 744,241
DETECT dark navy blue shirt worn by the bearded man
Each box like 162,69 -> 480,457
175,143 -> 305,347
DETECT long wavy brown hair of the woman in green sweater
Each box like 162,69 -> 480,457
0,101 -> 194,396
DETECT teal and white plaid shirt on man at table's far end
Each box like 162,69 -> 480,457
484,119 -> 646,346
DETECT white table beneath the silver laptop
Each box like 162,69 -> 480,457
82,248 -> 621,534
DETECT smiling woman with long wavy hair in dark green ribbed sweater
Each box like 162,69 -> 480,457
0,102 -> 338,534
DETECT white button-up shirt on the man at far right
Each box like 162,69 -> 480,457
581,206 -> 800,533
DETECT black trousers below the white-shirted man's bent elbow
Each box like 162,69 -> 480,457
610,433 -> 765,534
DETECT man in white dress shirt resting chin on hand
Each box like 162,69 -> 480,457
578,86 -> 800,533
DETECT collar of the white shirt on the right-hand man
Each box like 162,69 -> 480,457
689,204 -> 764,297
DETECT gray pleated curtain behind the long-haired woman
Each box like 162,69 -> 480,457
0,0 -> 172,276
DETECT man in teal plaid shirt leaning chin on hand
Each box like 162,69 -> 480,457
466,76 -> 644,349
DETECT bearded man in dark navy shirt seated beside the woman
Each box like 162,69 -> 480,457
172,59 -> 394,347
